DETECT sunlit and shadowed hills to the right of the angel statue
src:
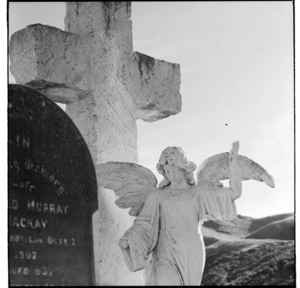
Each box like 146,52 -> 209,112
201,213 -> 295,286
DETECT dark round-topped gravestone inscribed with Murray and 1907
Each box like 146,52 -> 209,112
8,85 -> 97,286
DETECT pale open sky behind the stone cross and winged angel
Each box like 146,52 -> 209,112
8,1 -> 294,218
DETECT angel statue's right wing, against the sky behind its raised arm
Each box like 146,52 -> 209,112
196,152 -> 275,188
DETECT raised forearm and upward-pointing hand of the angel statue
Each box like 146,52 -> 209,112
229,141 -> 242,201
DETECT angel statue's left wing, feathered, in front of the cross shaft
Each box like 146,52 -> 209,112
96,162 -> 157,216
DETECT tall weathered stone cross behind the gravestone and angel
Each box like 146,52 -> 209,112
9,2 -> 181,285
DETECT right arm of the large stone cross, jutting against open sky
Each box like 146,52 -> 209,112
128,52 -> 182,122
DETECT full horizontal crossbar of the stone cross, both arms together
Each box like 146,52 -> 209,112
10,24 -> 181,122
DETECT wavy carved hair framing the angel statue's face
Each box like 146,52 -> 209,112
156,147 -> 197,188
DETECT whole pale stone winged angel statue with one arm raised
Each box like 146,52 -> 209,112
96,141 -> 275,285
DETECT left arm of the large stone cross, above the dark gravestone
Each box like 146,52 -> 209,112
9,24 -> 98,104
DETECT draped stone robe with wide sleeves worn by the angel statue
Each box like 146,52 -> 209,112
118,186 -> 237,285
